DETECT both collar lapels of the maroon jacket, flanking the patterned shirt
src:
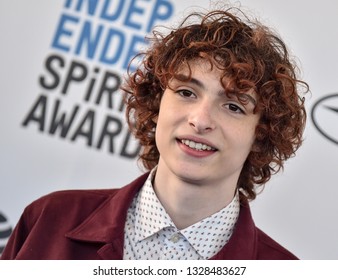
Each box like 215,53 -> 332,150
66,173 -> 258,260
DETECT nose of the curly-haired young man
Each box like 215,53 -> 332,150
189,101 -> 216,133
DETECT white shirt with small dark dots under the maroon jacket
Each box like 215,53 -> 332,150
123,172 -> 240,260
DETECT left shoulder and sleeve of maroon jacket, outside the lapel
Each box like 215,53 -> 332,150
1,189 -> 118,259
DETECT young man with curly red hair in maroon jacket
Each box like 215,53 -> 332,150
2,9 -> 307,259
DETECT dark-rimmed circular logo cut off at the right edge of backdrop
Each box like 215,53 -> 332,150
311,93 -> 338,145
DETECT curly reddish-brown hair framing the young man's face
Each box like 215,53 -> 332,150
123,7 -> 308,200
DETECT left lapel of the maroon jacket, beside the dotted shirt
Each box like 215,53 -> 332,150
66,173 -> 149,259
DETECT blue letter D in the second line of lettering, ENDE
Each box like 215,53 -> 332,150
100,29 -> 125,64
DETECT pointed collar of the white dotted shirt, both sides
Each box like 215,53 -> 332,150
133,168 -> 240,257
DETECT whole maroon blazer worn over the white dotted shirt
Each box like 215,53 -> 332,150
1,174 -> 297,260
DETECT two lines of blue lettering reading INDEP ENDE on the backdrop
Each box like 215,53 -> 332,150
51,0 -> 174,65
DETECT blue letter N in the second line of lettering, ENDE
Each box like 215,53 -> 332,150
75,21 -> 103,58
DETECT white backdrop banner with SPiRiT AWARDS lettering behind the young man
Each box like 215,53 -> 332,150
0,0 -> 338,259
